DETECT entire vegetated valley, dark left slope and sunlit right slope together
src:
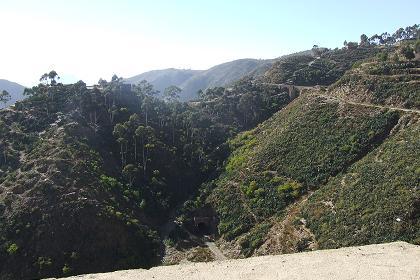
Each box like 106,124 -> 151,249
0,25 -> 420,279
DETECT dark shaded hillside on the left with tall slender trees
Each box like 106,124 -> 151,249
0,71 -> 290,279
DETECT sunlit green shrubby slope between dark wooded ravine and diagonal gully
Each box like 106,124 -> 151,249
210,95 -> 398,249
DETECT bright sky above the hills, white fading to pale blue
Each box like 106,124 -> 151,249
0,0 -> 420,86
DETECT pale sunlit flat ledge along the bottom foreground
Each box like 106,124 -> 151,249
47,242 -> 420,280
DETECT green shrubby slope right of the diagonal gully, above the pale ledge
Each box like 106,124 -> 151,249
303,116 -> 420,248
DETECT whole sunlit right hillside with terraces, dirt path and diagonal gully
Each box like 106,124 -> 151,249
207,43 -> 420,257
